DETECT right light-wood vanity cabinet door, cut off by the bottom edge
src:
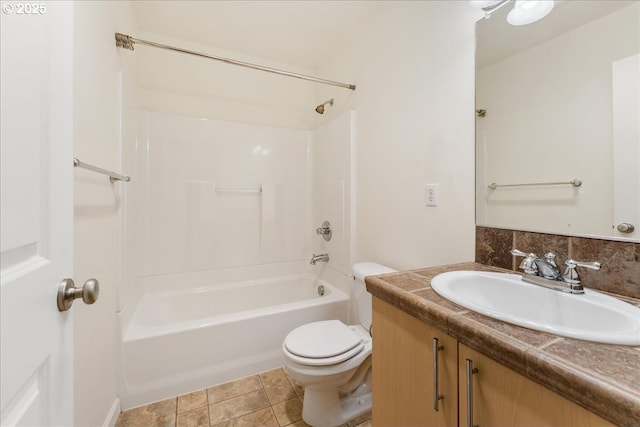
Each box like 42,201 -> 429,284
458,344 -> 613,427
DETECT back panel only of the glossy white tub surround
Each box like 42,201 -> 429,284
123,112 -> 312,310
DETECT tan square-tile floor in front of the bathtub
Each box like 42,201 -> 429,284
116,368 -> 372,427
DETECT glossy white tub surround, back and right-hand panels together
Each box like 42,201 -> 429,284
119,105 -> 355,309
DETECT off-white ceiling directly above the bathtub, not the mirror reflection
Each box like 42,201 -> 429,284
133,0 -> 380,69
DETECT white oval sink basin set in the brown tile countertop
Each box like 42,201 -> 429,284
431,271 -> 640,345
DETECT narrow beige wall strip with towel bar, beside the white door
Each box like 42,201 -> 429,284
69,1 -> 135,426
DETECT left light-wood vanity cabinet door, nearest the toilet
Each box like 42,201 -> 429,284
372,298 -> 458,427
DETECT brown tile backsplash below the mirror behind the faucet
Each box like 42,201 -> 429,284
475,226 -> 640,298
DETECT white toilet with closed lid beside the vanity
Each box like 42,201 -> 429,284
282,262 -> 396,427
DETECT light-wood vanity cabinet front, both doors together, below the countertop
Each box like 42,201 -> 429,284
372,298 -> 614,427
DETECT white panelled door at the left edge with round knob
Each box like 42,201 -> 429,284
0,1 -> 73,426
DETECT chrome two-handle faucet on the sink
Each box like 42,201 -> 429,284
511,249 -> 600,294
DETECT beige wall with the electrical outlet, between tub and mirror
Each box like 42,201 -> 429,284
316,1 -> 479,269
